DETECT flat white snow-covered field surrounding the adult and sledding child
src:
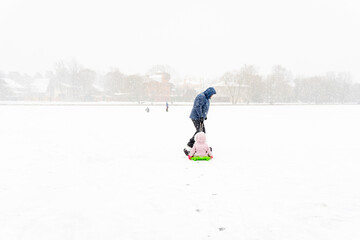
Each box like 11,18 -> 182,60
0,105 -> 360,240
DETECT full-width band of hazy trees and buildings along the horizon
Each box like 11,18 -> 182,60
0,61 -> 360,104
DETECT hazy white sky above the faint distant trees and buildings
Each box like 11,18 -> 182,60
0,0 -> 360,80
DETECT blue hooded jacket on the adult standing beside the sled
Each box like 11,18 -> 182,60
190,87 -> 216,120
